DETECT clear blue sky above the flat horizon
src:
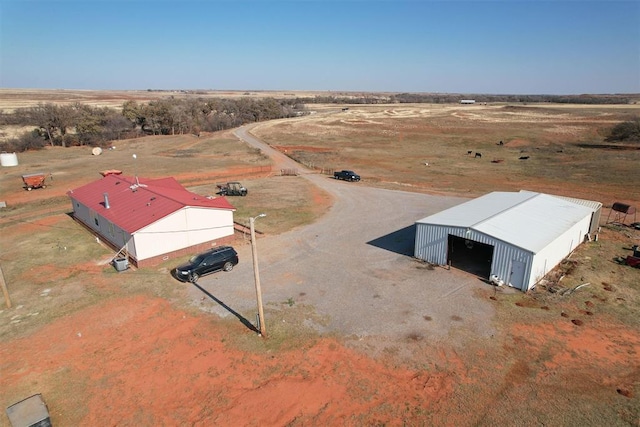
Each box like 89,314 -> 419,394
0,0 -> 640,94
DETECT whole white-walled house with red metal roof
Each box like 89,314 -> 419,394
67,174 -> 235,267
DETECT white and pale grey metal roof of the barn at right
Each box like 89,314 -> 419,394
417,191 -> 592,254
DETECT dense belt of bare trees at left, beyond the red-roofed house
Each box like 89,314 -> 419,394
0,98 -> 307,152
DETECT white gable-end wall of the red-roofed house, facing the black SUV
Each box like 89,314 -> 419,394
134,207 -> 233,260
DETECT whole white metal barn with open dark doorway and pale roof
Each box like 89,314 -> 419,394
414,191 -> 602,291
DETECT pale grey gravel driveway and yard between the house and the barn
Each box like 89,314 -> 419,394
190,123 -> 493,339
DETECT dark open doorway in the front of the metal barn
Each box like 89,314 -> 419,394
447,235 -> 493,279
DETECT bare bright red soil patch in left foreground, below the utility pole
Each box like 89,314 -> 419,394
0,297 -> 452,425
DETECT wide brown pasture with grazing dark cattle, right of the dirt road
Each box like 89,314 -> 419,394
255,104 -> 640,206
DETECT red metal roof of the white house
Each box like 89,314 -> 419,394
67,174 -> 235,233
